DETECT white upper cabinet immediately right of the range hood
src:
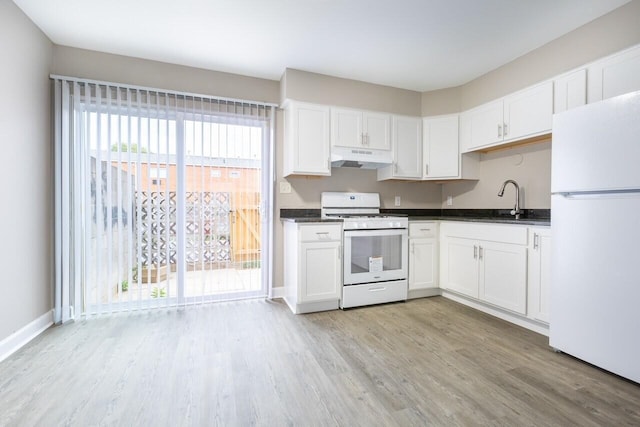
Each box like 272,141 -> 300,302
378,116 -> 422,181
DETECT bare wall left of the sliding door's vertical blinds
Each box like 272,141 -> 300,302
0,1 -> 53,341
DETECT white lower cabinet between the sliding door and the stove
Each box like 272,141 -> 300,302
284,222 -> 342,314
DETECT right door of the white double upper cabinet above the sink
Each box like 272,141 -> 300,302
503,82 -> 553,141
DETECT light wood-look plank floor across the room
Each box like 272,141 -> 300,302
0,297 -> 640,426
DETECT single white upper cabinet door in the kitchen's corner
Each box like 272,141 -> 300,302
423,114 -> 460,179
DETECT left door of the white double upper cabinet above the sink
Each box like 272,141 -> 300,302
468,99 -> 503,149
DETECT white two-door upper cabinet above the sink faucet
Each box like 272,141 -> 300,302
460,81 -> 553,152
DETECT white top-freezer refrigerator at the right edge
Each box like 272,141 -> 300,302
549,92 -> 640,382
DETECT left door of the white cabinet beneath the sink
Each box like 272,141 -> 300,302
441,237 -> 478,298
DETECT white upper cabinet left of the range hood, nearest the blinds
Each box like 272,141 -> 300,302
283,101 -> 331,176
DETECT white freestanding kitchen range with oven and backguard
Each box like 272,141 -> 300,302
320,192 -> 409,308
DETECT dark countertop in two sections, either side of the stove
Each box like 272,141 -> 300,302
280,209 -> 551,227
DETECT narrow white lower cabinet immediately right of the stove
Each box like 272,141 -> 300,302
409,221 -> 439,298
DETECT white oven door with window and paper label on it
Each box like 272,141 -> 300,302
343,228 -> 408,285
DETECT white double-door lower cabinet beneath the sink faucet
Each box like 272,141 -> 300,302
440,223 -> 527,315
